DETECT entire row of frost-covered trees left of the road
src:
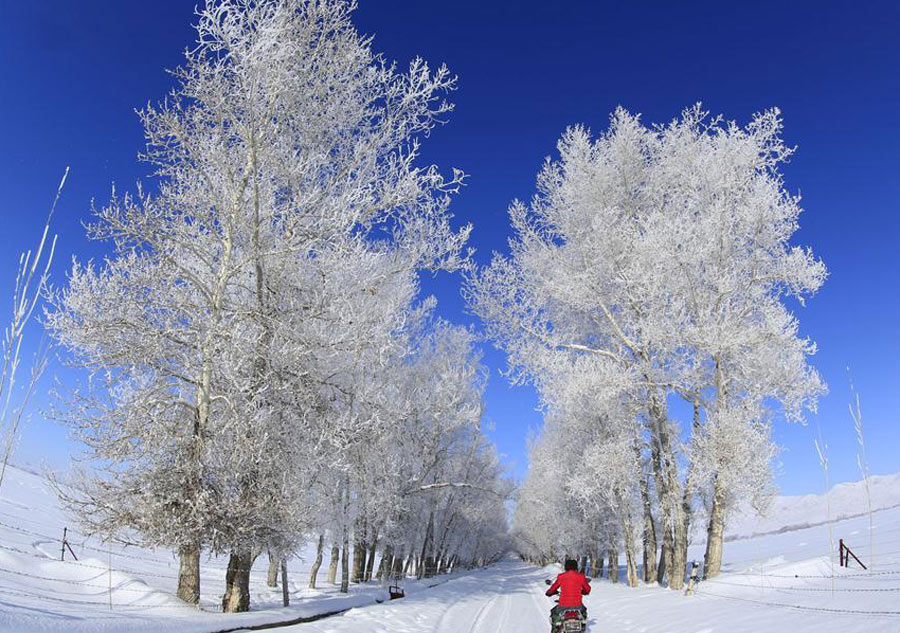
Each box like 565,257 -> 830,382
46,0 -> 507,611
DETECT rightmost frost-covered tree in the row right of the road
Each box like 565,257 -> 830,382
636,106 -> 826,576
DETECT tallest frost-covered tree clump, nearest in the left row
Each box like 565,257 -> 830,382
48,0 -> 478,610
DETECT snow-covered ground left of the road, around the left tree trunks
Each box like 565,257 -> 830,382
0,467 -> 460,633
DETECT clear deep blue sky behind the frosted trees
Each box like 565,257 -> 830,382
0,0 -> 900,493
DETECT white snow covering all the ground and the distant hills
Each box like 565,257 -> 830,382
0,468 -> 900,633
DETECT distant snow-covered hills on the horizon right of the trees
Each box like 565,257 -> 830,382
726,473 -> 900,538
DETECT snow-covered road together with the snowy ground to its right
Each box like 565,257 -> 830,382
287,508 -> 900,633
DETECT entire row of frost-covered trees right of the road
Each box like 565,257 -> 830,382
466,105 -> 826,589
